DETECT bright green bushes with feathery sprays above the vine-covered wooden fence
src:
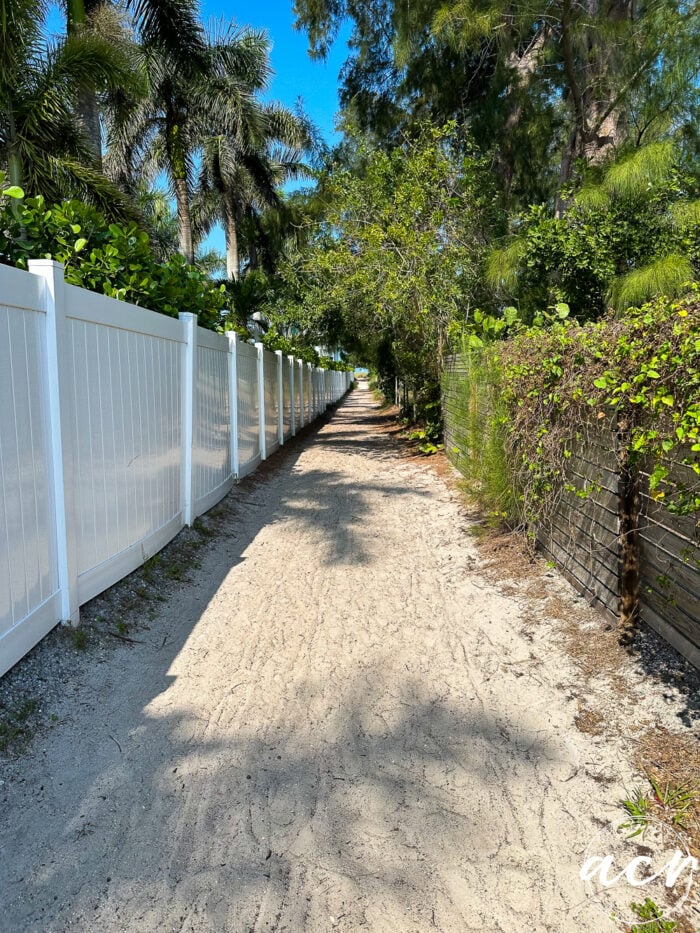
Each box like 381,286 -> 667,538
488,143 -> 700,323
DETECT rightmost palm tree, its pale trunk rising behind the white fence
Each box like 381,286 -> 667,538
197,99 -> 312,281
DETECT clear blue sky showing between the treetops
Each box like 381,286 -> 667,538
47,0 -> 347,251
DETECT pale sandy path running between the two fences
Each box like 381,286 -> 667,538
0,382 -> 636,933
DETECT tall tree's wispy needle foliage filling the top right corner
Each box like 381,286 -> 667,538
294,0 -> 700,210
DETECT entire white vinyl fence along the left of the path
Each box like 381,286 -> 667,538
0,260 -> 352,676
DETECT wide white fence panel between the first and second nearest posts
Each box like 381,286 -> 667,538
65,285 -> 183,603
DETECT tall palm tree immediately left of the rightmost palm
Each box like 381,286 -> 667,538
107,24 -> 269,262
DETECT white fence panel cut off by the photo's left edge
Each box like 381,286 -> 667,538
0,268 -> 59,675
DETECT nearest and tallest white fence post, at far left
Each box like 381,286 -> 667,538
28,259 -> 80,625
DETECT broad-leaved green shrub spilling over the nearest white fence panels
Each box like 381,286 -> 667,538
0,197 -> 226,327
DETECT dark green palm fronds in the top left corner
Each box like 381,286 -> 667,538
0,0 -> 131,217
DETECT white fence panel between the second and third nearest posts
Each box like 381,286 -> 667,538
192,327 -> 233,515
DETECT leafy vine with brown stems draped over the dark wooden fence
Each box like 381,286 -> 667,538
456,289 -> 700,526
